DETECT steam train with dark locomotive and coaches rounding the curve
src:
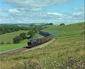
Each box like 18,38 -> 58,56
27,31 -> 53,48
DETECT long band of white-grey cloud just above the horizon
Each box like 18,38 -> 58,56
0,9 -> 85,24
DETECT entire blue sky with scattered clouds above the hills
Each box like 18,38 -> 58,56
0,0 -> 85,24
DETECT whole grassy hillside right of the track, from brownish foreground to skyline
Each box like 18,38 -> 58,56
0,23 -> 85,69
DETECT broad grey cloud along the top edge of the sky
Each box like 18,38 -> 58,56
6,0 -> 71,11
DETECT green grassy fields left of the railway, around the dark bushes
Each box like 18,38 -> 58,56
0,31 -> 43,52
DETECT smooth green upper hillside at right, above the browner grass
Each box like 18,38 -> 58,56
43,22 -> 84,38
